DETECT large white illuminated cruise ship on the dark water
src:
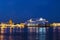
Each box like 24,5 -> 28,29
25,18 -> 48,27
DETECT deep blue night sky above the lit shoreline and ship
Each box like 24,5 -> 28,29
0,0 -> 60,23
